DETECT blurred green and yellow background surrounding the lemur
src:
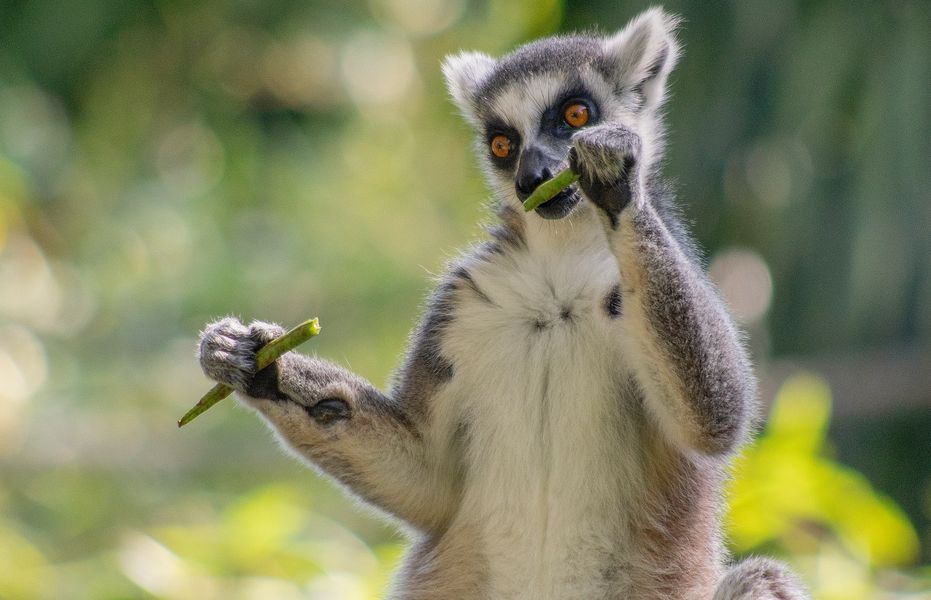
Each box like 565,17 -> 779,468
0,0 -> 931,600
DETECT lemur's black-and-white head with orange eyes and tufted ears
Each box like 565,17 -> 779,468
443,8 -> 679,219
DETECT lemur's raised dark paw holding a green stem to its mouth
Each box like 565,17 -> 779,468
569,124 -> 641,227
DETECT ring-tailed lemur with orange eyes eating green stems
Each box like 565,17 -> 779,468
199,9 -> 805,600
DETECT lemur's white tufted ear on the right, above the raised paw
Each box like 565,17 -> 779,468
604,8 -> 679,110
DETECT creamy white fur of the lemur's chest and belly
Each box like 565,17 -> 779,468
443,243 -> 642,599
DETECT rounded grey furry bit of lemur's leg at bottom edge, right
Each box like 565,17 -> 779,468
713,558 -> 808,600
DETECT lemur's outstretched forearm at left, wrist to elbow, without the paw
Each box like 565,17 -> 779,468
248,353 -> 455,532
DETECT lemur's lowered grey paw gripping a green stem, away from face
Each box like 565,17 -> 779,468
197,317 -> 285,393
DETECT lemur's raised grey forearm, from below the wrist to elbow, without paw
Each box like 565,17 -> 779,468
606,202 -> 755,453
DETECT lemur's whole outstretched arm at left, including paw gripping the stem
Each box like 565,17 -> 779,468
199,317 -> 456,532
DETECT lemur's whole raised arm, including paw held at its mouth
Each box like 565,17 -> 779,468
570,124 -> 755,453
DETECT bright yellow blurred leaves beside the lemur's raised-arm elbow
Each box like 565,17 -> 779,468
728,375 -> 919,600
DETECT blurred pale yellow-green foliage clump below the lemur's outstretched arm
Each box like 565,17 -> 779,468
136,483 -> 402,599
